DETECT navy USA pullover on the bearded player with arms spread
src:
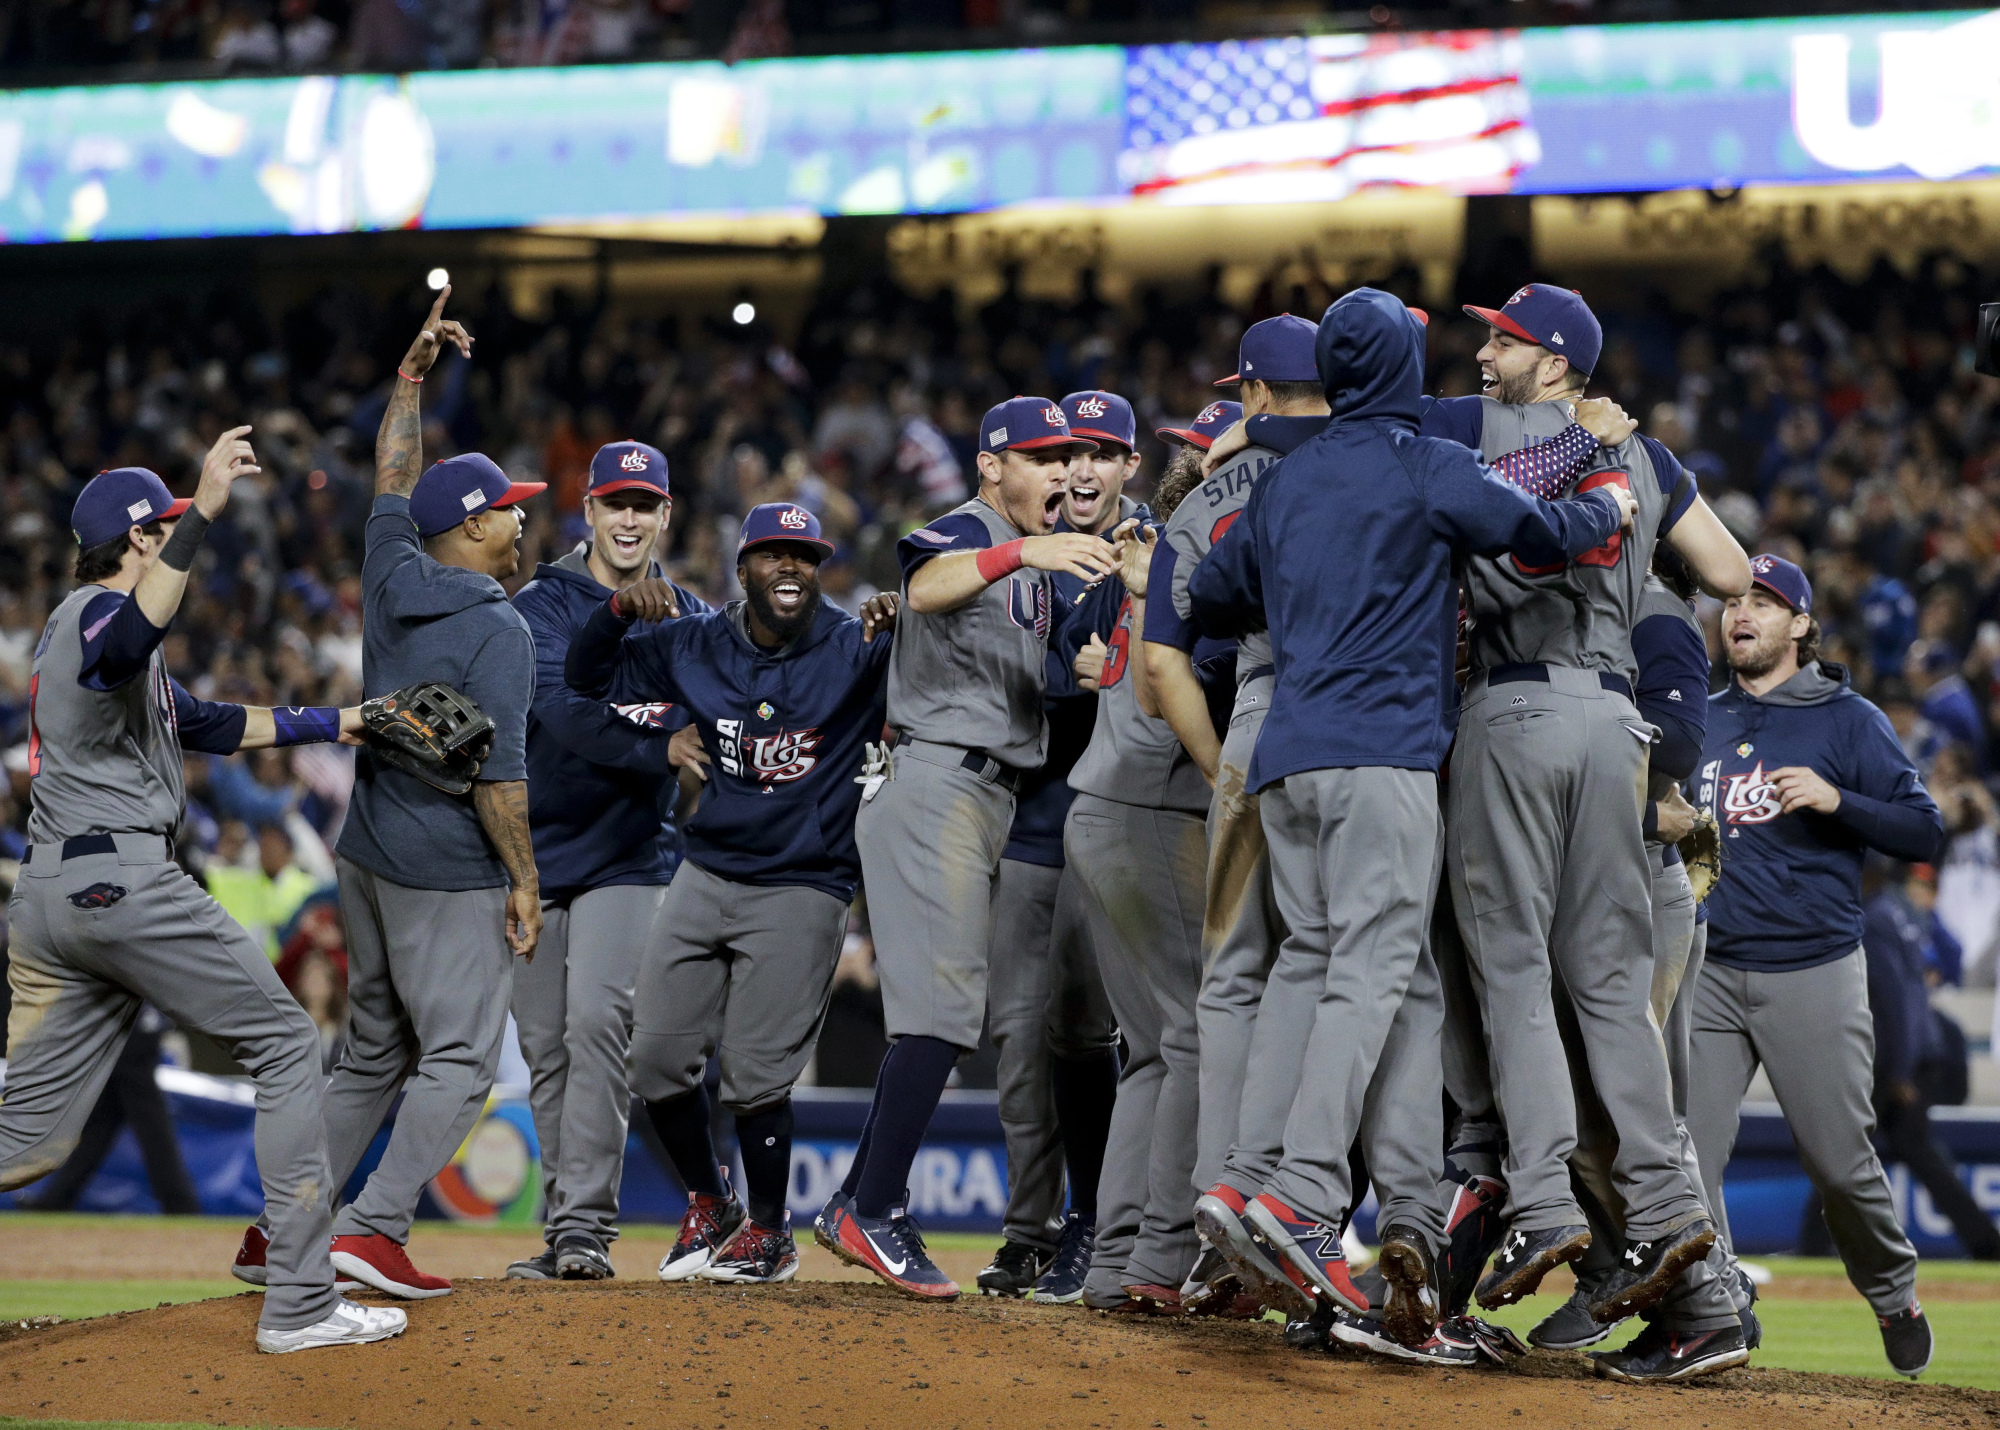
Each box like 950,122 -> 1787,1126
566,600 -> 892,900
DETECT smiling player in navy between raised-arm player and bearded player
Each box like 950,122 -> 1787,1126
506,442 -> 708,1280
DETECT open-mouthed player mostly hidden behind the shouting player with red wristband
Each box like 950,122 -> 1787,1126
978,392 -> 1142,1304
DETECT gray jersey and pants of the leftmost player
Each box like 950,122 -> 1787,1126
0,586 -> 338,1330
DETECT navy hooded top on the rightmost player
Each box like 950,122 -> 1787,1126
1688,660 -> 1944,974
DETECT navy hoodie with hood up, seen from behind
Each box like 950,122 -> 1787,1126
1188,288 -> 1618,790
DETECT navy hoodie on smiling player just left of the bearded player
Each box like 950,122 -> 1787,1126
514,542 -> 708,902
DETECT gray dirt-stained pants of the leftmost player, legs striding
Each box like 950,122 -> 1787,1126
0,834 -> 340,1330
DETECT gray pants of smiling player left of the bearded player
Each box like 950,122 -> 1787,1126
514,884 -> 666,1246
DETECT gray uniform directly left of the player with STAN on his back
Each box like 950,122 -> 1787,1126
1062,584 -> 1208,1298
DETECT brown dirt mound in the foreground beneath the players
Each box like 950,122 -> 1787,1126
0,1282 -> 2000,1430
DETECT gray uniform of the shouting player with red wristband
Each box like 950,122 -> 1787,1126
854,498 -> 1062,1048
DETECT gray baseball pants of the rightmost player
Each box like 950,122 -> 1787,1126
1688,948 -> 1916,1316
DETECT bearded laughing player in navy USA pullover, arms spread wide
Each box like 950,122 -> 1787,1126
568,502 -> 896,1282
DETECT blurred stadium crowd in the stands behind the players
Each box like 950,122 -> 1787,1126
0,243 -> 2000,1084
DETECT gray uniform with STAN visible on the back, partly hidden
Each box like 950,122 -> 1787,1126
1146,446 -> 1284,1192
